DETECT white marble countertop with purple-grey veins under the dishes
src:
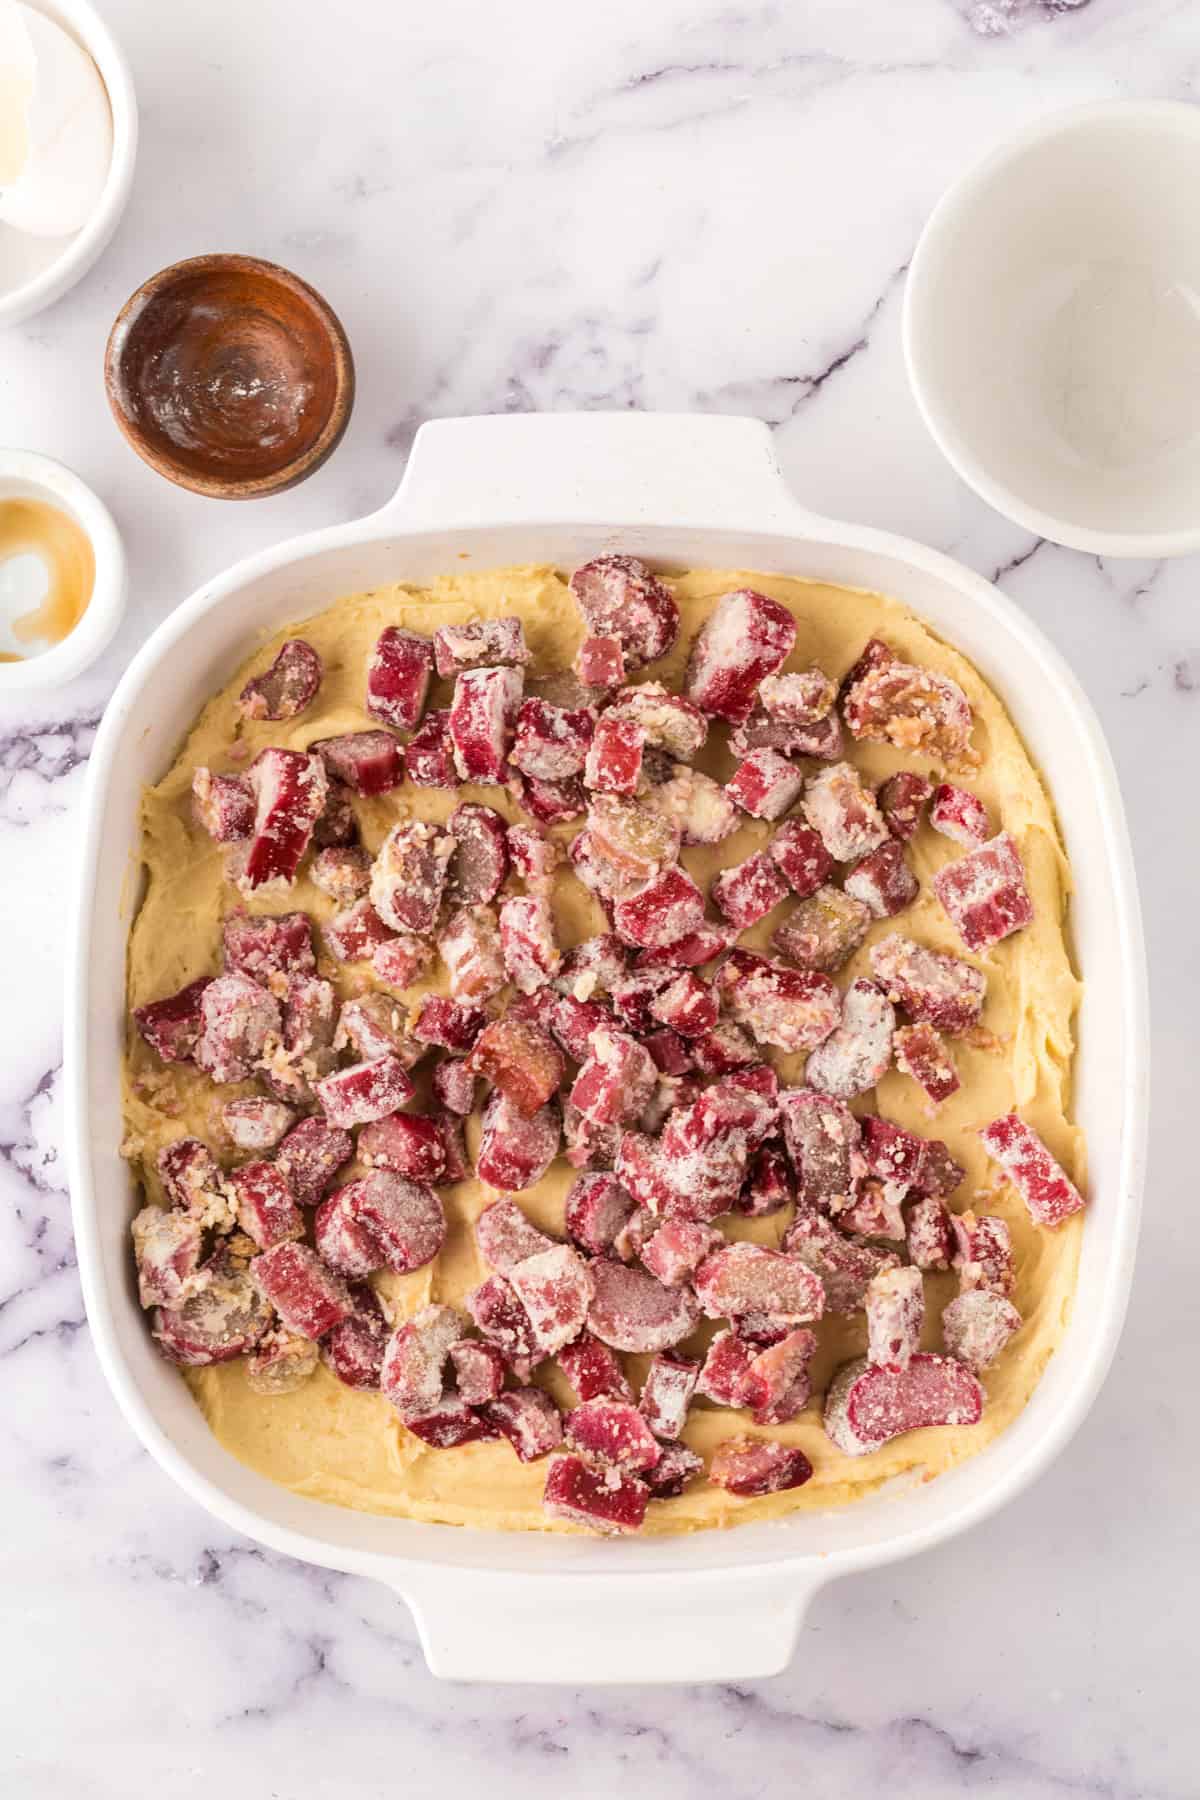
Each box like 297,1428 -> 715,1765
0,0 -> 1200,1800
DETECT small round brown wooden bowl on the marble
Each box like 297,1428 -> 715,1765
104,256 -> 354,500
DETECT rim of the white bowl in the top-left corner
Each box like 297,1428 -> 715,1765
0,0 -> 137,326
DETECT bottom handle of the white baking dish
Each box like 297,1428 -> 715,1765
394,1568 -> 822,1685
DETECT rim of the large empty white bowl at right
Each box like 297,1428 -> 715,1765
901,101 -> 1200,558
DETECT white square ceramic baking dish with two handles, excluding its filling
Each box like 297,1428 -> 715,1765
67,414 -> 1148,1681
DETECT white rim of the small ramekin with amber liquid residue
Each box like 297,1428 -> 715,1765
0,448 -> 126,697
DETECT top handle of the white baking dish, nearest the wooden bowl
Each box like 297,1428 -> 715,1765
376,412 -> 831,533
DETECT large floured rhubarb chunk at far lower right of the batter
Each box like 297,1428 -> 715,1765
824,1352 -> 984,1456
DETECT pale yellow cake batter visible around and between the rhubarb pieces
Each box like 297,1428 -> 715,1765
126,567 -> 1083,1532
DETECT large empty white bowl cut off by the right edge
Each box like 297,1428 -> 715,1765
903,101 -> 1200,556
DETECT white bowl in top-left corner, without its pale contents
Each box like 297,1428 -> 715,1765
0,0 -> 137,326
